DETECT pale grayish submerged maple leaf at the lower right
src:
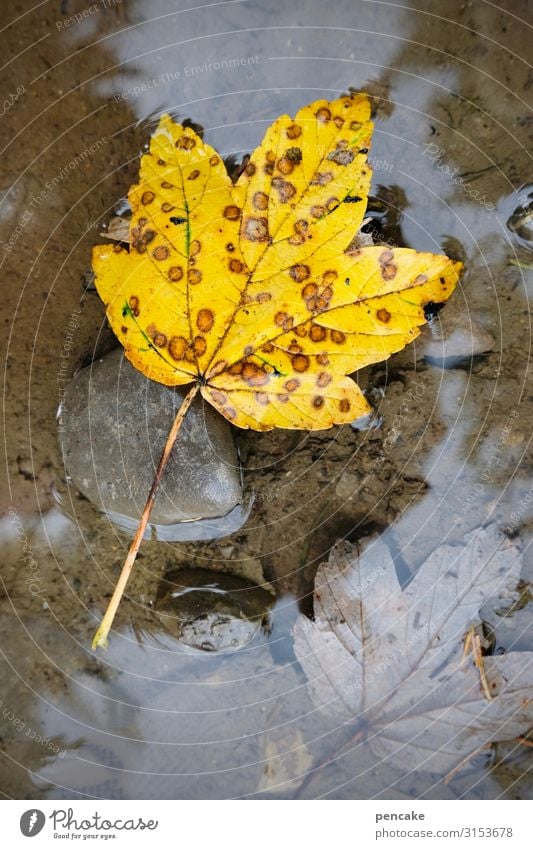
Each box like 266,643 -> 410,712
294,525 -> 533,774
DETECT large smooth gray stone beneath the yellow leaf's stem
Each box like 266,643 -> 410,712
59,349 -> 243,528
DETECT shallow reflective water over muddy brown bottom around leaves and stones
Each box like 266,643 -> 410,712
0,0 -> 533,798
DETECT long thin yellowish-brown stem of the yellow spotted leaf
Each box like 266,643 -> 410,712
92,383 -> 200,650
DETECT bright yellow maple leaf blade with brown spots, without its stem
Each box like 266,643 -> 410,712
93,94 -> 461,430
